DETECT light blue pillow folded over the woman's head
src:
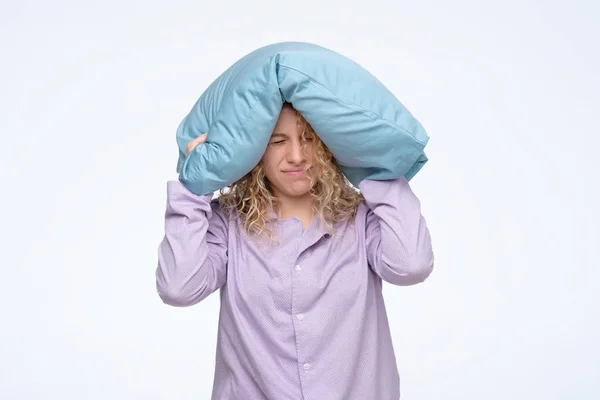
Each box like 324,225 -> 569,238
176,42 -> 429,195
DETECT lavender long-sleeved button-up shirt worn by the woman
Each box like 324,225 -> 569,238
156,178 -> 434,400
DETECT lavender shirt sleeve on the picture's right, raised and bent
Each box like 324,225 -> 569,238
359,177 -> 434,286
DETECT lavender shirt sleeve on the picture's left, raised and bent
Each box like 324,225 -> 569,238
156,181 -> 228,307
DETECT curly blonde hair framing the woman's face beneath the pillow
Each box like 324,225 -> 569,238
219,103 -> 363,240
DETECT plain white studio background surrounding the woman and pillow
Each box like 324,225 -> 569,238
0,0 -> 600,400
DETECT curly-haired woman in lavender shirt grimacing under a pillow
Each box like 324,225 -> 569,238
156,104 -> 433,400
